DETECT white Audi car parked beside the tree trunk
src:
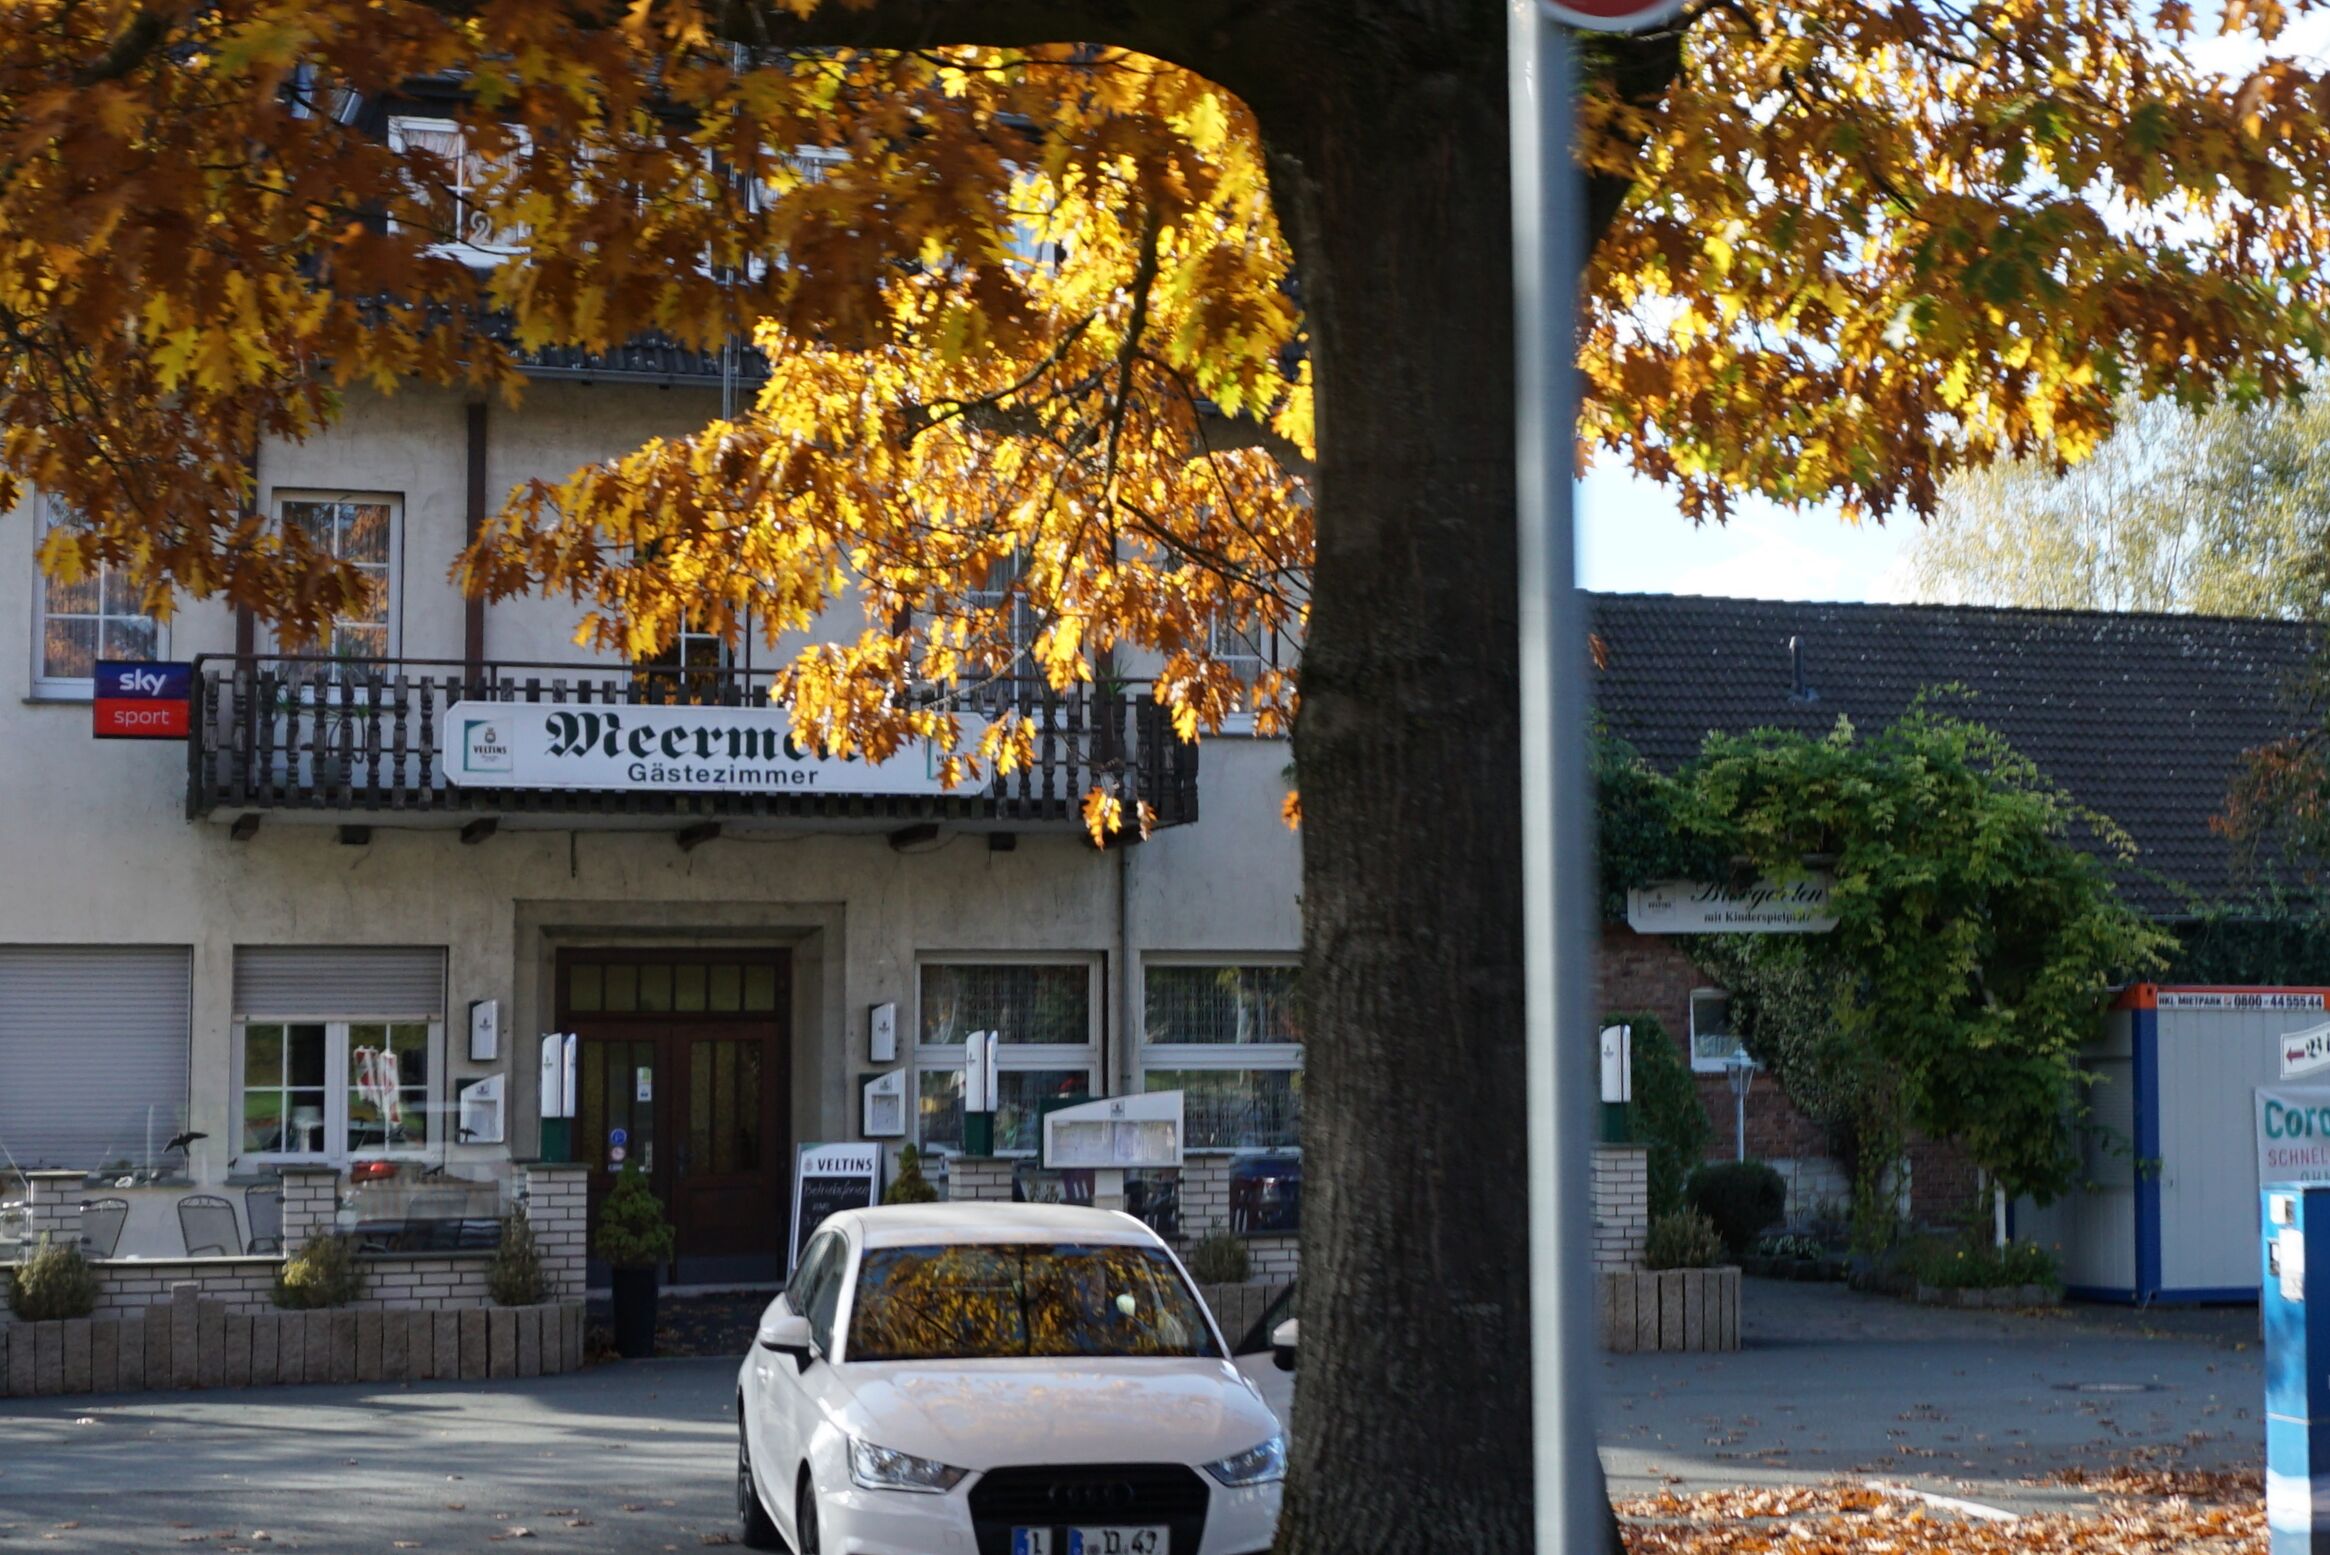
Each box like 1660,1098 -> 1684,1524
736,1203 -> 1286,1555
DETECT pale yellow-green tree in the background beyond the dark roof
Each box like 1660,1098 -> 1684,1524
1911,394 -> 2330,615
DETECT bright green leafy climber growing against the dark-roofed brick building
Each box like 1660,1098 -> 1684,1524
1680,699 -> 2172,1212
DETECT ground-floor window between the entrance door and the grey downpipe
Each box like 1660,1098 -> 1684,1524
916,961 -> 1100,1154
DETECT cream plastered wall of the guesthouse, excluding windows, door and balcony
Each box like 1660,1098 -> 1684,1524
0,382 -> 1300,1180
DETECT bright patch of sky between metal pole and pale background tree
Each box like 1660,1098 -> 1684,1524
1577,469 -> 1911,604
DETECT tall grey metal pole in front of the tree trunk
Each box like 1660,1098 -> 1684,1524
1505,0 -> 1608,1555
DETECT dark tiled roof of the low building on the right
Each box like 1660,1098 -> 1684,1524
1589,594 -> 2314,914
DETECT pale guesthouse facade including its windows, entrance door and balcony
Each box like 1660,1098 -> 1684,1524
0,370 -> 1302,1282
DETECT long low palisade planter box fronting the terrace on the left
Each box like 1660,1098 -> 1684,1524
0,1285 -> 583,1396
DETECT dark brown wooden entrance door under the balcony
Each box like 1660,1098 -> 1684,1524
557,951 -> 792,1285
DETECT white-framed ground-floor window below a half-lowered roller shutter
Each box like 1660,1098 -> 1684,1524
238,1021 -> 443,1161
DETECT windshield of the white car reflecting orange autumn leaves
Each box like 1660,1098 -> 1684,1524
848,1243 -> 1219,1361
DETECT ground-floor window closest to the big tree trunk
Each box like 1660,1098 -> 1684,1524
1142,963 -> 1302,1149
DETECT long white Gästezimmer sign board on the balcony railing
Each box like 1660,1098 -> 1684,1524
445,702 -> 979,795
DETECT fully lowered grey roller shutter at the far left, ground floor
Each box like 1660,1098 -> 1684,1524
0,944 -> 193,1170
